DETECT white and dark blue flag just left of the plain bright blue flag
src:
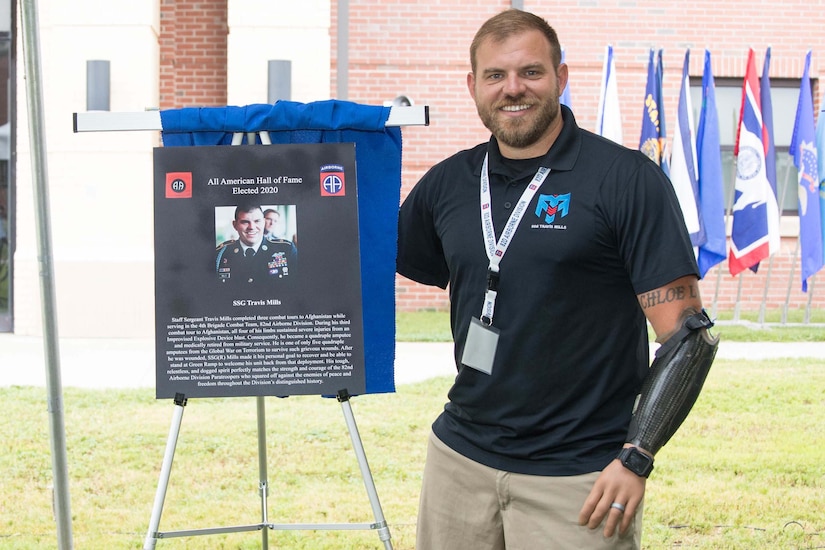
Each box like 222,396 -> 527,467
670,50 -> 705,250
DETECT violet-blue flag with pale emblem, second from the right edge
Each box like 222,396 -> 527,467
788,50 -> 823,292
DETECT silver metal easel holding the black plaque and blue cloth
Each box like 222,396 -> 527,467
73,106 -> 429,550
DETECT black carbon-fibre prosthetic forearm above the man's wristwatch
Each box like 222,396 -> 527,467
627,310 -> 719,455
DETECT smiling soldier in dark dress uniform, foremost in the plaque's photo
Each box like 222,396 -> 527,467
215,205 -> 298,284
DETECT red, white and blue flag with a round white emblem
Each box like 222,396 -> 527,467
728,49 -> 779,275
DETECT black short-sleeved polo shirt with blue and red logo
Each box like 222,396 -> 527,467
397,106 -> 698,475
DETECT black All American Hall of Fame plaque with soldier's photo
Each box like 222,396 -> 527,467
154,143 -> 365,398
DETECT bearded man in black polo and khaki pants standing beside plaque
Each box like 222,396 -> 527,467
397,10 -> 717,550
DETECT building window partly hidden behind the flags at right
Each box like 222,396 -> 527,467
690,77 -> 800,216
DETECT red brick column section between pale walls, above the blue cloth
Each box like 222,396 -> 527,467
158,0 -> 228,109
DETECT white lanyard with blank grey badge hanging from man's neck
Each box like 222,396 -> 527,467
461,155 -> 550,374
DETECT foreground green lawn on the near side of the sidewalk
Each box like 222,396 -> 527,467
0,359 -> 825,550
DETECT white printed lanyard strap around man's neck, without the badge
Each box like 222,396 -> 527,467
481,155 -> 550,325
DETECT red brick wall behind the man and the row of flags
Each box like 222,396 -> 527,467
330,0 -> 825,311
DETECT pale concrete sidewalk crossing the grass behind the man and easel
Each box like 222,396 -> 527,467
0,334 -> 825,389
